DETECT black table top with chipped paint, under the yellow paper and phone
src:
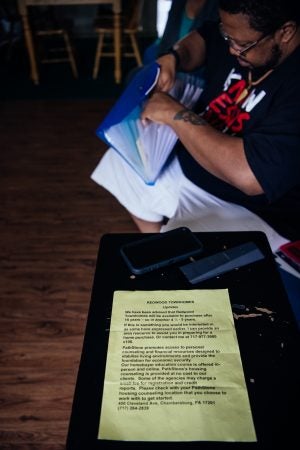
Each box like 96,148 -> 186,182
67,232 -> 300,450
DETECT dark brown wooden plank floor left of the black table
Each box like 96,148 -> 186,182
0,100 -> 136,450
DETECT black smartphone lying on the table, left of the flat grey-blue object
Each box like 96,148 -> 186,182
120,227 -> 203,275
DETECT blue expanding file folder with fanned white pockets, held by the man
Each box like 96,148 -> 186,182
96,63 -> 202,184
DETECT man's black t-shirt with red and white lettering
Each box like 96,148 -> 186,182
177,23 -> 300,240
